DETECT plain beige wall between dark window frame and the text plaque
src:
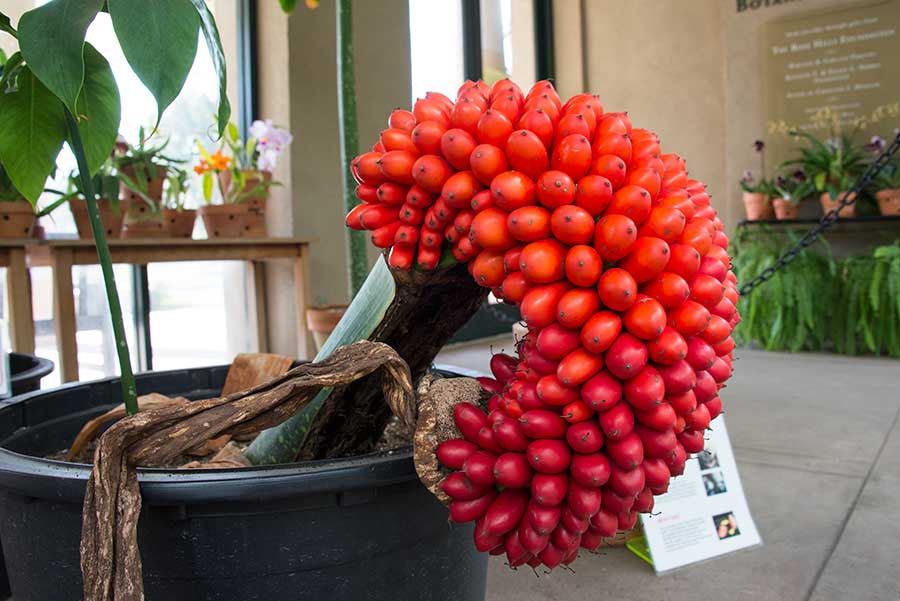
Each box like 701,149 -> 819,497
553,0 -> 868,231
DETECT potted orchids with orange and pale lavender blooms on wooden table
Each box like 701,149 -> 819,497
194,120 -> 293,238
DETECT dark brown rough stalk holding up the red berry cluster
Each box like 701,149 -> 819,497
298,264 -> 488,460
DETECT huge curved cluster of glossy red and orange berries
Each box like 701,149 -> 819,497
347,80 -> 740,568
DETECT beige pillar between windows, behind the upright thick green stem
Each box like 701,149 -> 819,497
251,0 -> 411,354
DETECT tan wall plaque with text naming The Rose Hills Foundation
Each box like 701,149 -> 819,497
762,0 -> 900,164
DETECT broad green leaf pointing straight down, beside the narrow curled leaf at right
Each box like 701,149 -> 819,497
109,0 -> 200,123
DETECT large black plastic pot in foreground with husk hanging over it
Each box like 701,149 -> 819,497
0,367 -> 487,601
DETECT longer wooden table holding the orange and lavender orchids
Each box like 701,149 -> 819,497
26,238 -> 315,382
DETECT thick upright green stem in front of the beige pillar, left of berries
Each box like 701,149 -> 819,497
335,0 -> 368,298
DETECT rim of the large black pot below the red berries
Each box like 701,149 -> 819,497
0,370 -> 417,505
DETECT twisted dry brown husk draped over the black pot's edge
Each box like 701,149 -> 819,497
81,341 -> 415,601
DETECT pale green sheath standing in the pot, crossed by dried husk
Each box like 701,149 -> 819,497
246,259 -> 396,465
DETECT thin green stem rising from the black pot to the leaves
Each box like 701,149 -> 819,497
65,108 -> 138,415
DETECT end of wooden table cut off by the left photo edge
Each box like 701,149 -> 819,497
0,238 -> 37,355
